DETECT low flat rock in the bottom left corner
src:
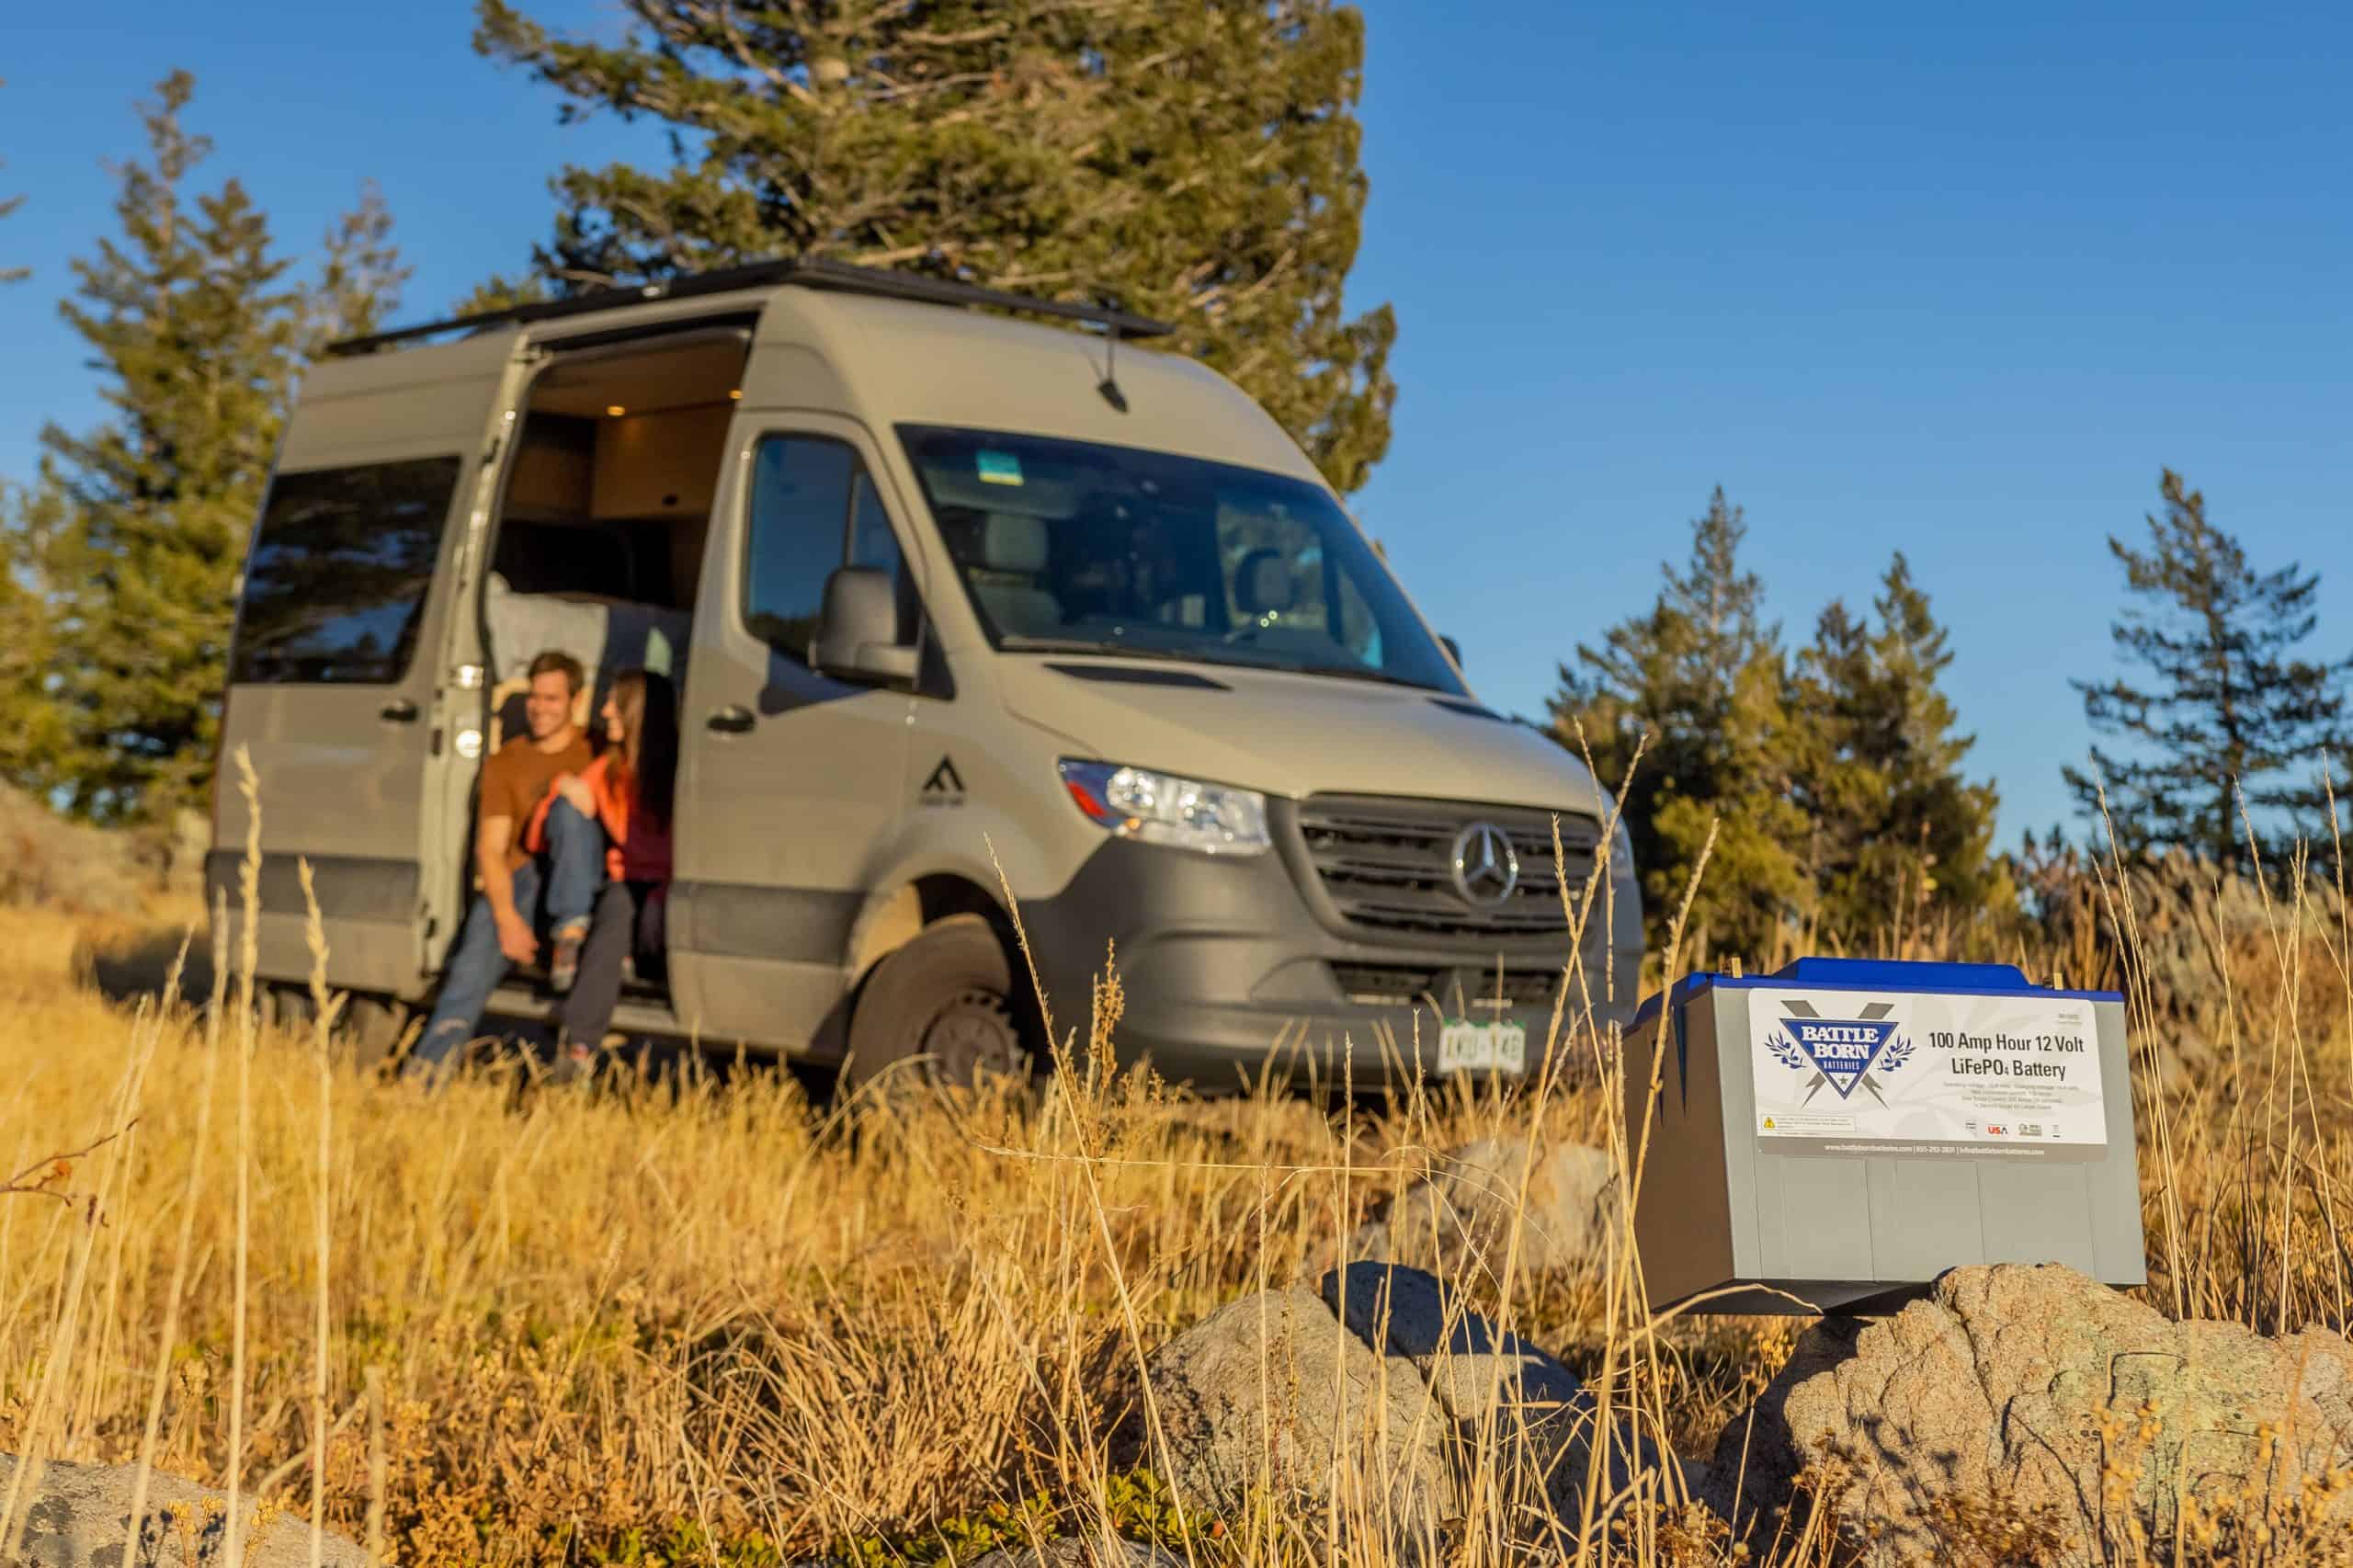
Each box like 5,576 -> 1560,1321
0,1455 -> 367,1568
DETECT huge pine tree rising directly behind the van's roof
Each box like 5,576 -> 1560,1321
473,0 -> 1395,490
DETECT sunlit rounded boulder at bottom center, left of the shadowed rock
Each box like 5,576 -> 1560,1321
1142,1286 -> 1449,1542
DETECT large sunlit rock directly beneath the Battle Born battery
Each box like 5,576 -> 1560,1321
1703,1265 -> 2353,1563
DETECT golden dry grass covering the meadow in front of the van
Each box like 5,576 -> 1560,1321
0,805 -> 2353,1565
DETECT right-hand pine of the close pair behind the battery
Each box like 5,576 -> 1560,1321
1790,551 -> 2017,947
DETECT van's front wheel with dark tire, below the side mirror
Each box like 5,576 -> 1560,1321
842,915 -> 1033,1087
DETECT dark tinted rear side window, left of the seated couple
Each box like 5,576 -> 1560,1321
228,445 -> 461,685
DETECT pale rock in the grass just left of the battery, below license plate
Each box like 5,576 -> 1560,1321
1323,1137 -> 1617,1280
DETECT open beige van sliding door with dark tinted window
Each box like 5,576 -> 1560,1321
205,330 -> 525,998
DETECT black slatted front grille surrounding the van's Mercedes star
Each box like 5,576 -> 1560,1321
1299,796 -> 1602,939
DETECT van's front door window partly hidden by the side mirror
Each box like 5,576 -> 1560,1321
744,436 -> 915,664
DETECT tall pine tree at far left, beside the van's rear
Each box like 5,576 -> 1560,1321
14,71 -> 400,819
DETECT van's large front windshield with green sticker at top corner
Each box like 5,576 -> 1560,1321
899,426 -> 1463,697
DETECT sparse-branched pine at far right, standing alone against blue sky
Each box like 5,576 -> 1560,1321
2062,469 -> 2353,867
